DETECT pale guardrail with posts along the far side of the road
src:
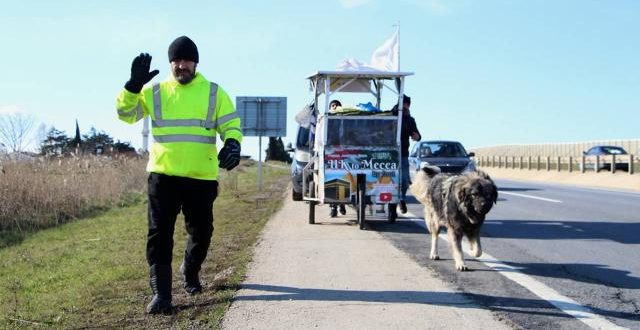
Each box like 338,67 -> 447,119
475,154 -> 640,174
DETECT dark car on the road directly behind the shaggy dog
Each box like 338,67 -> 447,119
409,141 -> 476,176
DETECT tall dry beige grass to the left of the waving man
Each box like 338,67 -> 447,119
0,156 -> 146,236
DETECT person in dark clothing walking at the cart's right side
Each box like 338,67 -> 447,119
392,95 -> 422,214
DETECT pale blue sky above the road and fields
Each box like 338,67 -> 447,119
0,0 -> 640,159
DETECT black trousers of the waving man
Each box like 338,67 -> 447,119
147,173 -> 218,270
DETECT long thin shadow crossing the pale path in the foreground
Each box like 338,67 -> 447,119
235,283 -> 639,320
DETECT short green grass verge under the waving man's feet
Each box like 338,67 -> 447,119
0,162 -> 289,329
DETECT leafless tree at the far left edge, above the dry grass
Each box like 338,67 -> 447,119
0,112 -> 35,152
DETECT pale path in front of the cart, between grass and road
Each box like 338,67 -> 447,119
222,200 -> 510,330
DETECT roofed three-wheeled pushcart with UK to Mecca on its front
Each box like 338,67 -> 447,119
302,71 -> 413,229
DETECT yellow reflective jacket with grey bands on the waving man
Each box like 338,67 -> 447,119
116,73 -> 242,180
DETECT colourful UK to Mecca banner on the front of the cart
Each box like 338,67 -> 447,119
324,148 -> 400,203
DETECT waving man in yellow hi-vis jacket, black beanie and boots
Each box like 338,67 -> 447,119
116,36 -> 242,314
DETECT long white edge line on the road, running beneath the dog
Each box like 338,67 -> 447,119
404,212 -> 626,329
